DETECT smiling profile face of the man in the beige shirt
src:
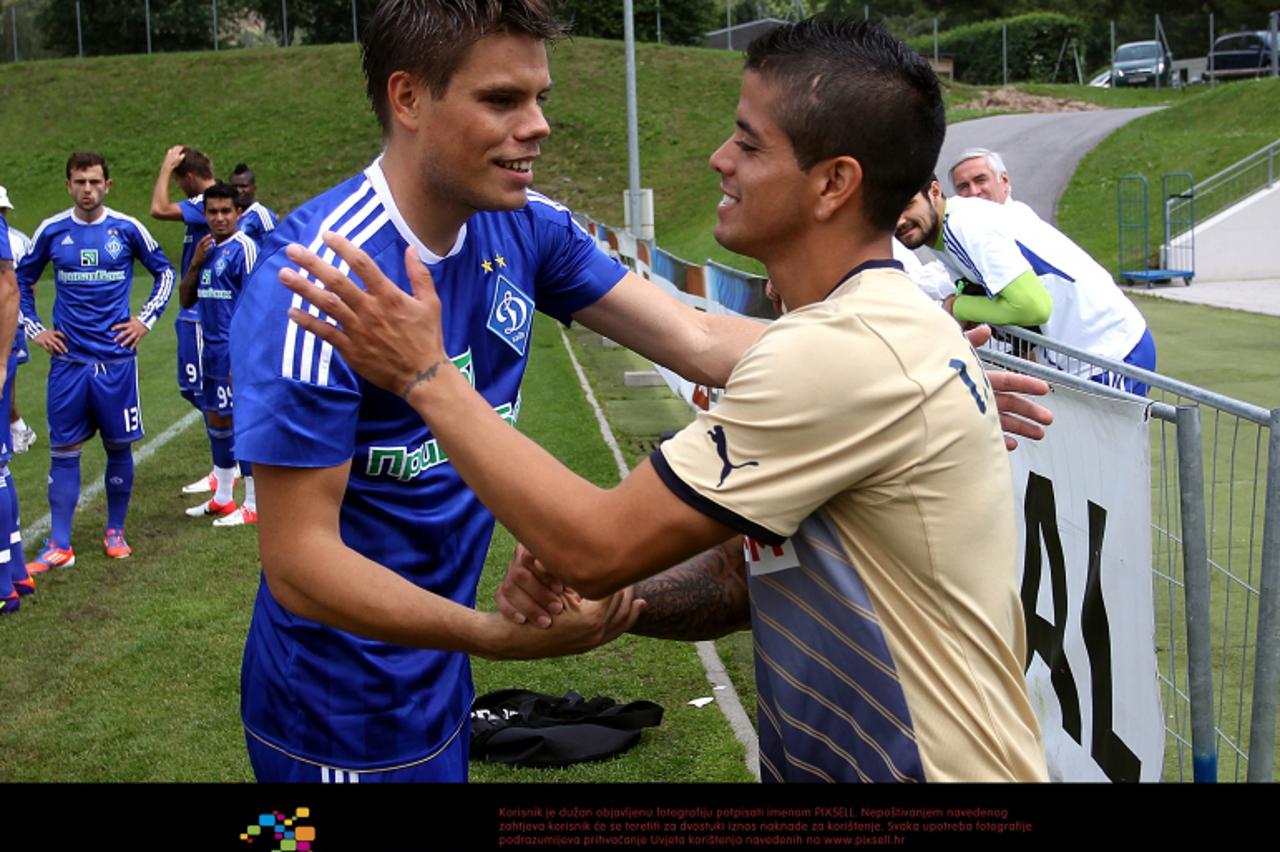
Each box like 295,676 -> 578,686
710,70 -> 810,262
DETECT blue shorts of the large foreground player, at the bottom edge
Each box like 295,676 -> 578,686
244,719 -> 471,784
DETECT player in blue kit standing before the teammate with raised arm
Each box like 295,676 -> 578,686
178,183 -> 257,527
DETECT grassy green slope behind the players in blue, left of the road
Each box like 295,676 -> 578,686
0,38 -> 749,265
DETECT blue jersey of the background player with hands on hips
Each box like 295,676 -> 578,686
18,207 -> 174,361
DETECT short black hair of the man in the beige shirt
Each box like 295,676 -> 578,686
746,15 -> 946,230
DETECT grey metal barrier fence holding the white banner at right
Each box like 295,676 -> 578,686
982,322 -> 1280,782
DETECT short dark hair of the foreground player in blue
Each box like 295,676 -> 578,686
361,0 -> 566,132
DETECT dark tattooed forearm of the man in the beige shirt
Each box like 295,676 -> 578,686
631,536 -> 751,642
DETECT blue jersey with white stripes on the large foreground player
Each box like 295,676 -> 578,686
232,156 -> 625,769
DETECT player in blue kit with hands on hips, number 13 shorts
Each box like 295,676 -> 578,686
18,152 -> 174,573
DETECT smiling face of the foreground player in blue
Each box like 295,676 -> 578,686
415,33 -> 550,218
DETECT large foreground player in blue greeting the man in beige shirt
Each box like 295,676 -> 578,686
232,0 -> 1049,783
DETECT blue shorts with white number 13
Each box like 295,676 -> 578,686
47,357 -> 142,449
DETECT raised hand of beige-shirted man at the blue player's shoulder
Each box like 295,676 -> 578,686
280,232 -> 448,397
